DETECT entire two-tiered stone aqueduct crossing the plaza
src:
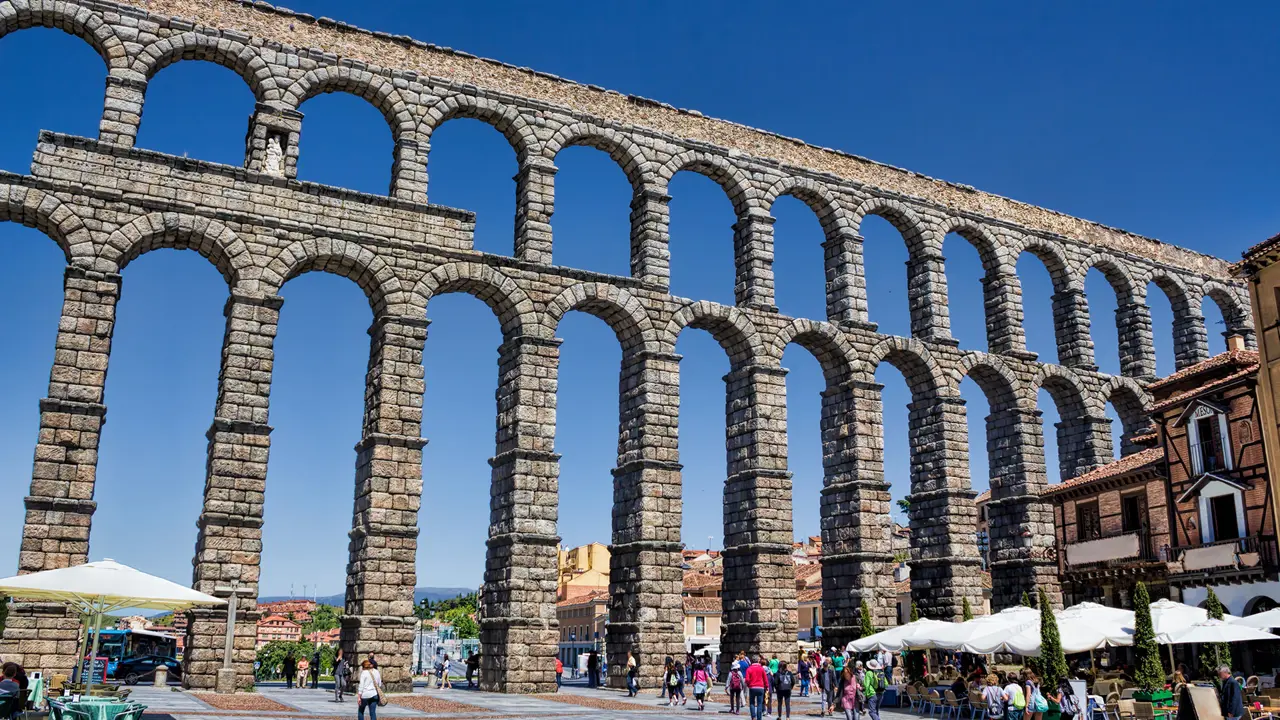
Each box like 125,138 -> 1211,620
0,0 -> 1253,692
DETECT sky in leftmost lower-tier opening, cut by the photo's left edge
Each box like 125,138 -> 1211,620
0,224 -> 67,573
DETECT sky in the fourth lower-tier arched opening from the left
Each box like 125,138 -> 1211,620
417,293 -> 503,594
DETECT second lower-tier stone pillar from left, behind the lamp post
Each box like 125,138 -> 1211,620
182,291 -> 284,691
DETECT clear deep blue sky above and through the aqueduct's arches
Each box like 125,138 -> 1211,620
0,0 -> 1280,594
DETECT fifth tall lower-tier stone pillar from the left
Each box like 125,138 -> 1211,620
605,350 -> 685,688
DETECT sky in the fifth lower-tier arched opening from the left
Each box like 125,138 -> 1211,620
556,313 -> 622,547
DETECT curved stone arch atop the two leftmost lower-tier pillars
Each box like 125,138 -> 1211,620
99,213 -> 253,287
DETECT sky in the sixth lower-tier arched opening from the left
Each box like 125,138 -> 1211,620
676,328 -> 730,550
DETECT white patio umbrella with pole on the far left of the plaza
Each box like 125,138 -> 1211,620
0,559 -> 227,692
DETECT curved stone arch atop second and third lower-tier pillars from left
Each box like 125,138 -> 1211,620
262,237 -> 409,318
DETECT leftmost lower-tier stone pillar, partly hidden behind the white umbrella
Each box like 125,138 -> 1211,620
0,265 -> 120,674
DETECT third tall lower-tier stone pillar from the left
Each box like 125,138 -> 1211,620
342,315 -> 428,692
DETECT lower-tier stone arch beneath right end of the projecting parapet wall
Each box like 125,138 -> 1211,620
410,261 -> 537,340
